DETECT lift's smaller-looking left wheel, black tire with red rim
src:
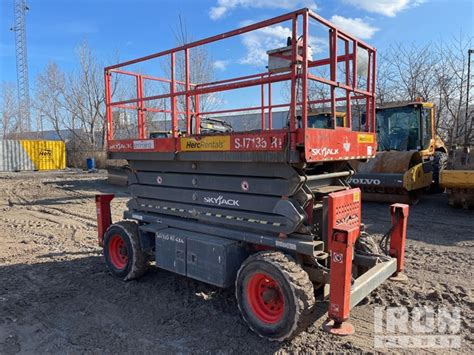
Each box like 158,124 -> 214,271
104,221 -> 148,281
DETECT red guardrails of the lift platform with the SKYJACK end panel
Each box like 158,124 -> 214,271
105,9 -> 376,161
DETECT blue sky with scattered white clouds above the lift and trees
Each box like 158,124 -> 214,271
0,0 -> 474,100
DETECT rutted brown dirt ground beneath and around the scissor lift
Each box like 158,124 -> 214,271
0,171 -> 474,354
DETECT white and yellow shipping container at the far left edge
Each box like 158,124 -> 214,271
0,140 -> 66,171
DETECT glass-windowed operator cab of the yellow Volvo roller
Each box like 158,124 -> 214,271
376,102 -> 433,151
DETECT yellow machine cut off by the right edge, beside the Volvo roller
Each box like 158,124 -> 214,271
440,146 -> 474,209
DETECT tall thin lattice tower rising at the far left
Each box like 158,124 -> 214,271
11,0 -> 31,132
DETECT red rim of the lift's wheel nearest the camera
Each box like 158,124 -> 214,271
246,273 -> 285,324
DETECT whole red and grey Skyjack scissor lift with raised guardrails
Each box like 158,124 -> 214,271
96,9 -> 408,341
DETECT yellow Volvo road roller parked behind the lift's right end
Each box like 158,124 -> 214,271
350,101 -> 448,204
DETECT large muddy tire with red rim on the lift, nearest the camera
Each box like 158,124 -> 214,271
235,251 -> 315,341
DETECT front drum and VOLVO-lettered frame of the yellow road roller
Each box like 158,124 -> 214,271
349,151 -> 433,204
